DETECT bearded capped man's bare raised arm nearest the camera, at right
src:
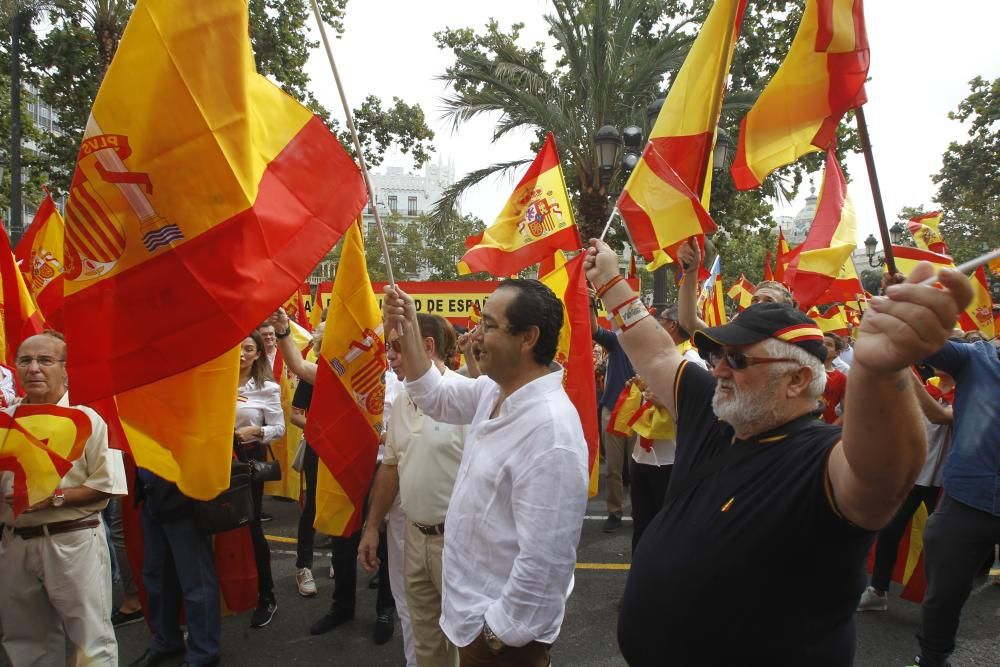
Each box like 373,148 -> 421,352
829,262 -> 972,530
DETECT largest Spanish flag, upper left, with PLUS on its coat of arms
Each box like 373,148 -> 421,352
64,0 -> 366,403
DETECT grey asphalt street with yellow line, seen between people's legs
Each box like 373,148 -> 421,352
0,486 -> 1000,667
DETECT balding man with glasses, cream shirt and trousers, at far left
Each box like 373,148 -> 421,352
0,333 -> 128,667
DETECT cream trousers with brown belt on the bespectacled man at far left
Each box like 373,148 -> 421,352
0,525 -> 118,667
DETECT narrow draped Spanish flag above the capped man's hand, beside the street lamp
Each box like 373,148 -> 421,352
618,0 -> 746,264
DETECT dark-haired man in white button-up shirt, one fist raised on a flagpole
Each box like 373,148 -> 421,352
384,279 -> 588,667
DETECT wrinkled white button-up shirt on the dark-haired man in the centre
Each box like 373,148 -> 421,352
406,367 -> 588,646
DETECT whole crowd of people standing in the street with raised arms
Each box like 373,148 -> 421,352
0,236 -> 1000,667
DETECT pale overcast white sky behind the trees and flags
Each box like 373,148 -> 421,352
309,0 -> 1000,250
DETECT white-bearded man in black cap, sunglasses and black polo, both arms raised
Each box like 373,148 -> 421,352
585,241 -> 971,667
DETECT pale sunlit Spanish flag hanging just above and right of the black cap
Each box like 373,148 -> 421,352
785,149 -> 858,308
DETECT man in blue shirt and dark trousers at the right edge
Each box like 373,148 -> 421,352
917,341 -> 1000,667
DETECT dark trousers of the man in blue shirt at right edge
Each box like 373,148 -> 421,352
917,494 -> 1000,667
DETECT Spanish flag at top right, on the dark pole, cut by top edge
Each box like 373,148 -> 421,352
732,0 -> 869,190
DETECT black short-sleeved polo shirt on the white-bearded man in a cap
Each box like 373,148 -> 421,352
618,363 -> 874,667
